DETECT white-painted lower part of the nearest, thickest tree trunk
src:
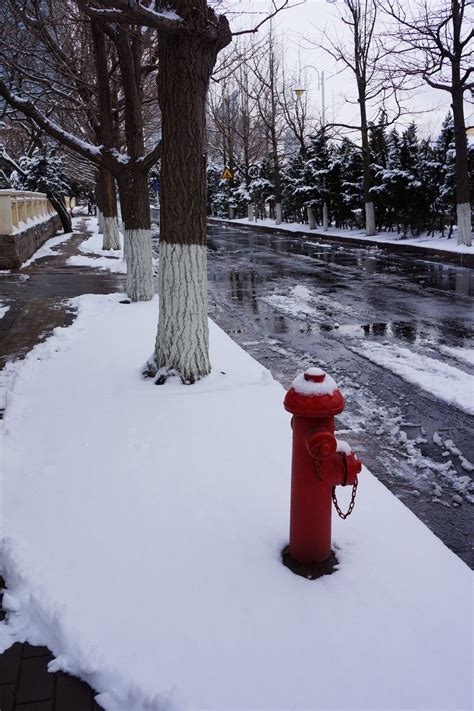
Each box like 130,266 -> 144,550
154,242 -> 211,383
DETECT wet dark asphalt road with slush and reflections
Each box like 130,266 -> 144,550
208,226 -> 474,567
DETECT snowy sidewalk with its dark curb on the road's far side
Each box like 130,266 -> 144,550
208,217 -> 474,267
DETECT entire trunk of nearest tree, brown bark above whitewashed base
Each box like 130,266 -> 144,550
154,33 -> 216,383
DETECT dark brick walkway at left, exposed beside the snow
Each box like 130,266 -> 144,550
0,214 -> 124,711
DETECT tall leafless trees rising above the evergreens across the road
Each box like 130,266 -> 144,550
210,0 -> 474,244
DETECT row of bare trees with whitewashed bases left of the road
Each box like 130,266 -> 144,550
0,0 -> 264,383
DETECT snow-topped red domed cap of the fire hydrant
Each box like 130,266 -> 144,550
283,368 -> 345,417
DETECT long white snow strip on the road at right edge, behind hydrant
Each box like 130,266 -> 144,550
354,341 -> 474,415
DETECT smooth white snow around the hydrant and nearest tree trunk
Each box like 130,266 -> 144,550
0,294 -> 472,711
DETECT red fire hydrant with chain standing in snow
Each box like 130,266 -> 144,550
283,368 -> 362,578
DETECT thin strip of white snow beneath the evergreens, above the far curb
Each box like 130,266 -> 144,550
214,217 -> 474,254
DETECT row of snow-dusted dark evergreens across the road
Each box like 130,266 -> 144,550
208,115 -> 474,236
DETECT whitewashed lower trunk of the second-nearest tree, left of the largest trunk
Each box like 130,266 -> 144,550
124,229 -> 155,301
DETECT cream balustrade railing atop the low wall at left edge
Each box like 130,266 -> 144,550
0,190 -> 55,235
